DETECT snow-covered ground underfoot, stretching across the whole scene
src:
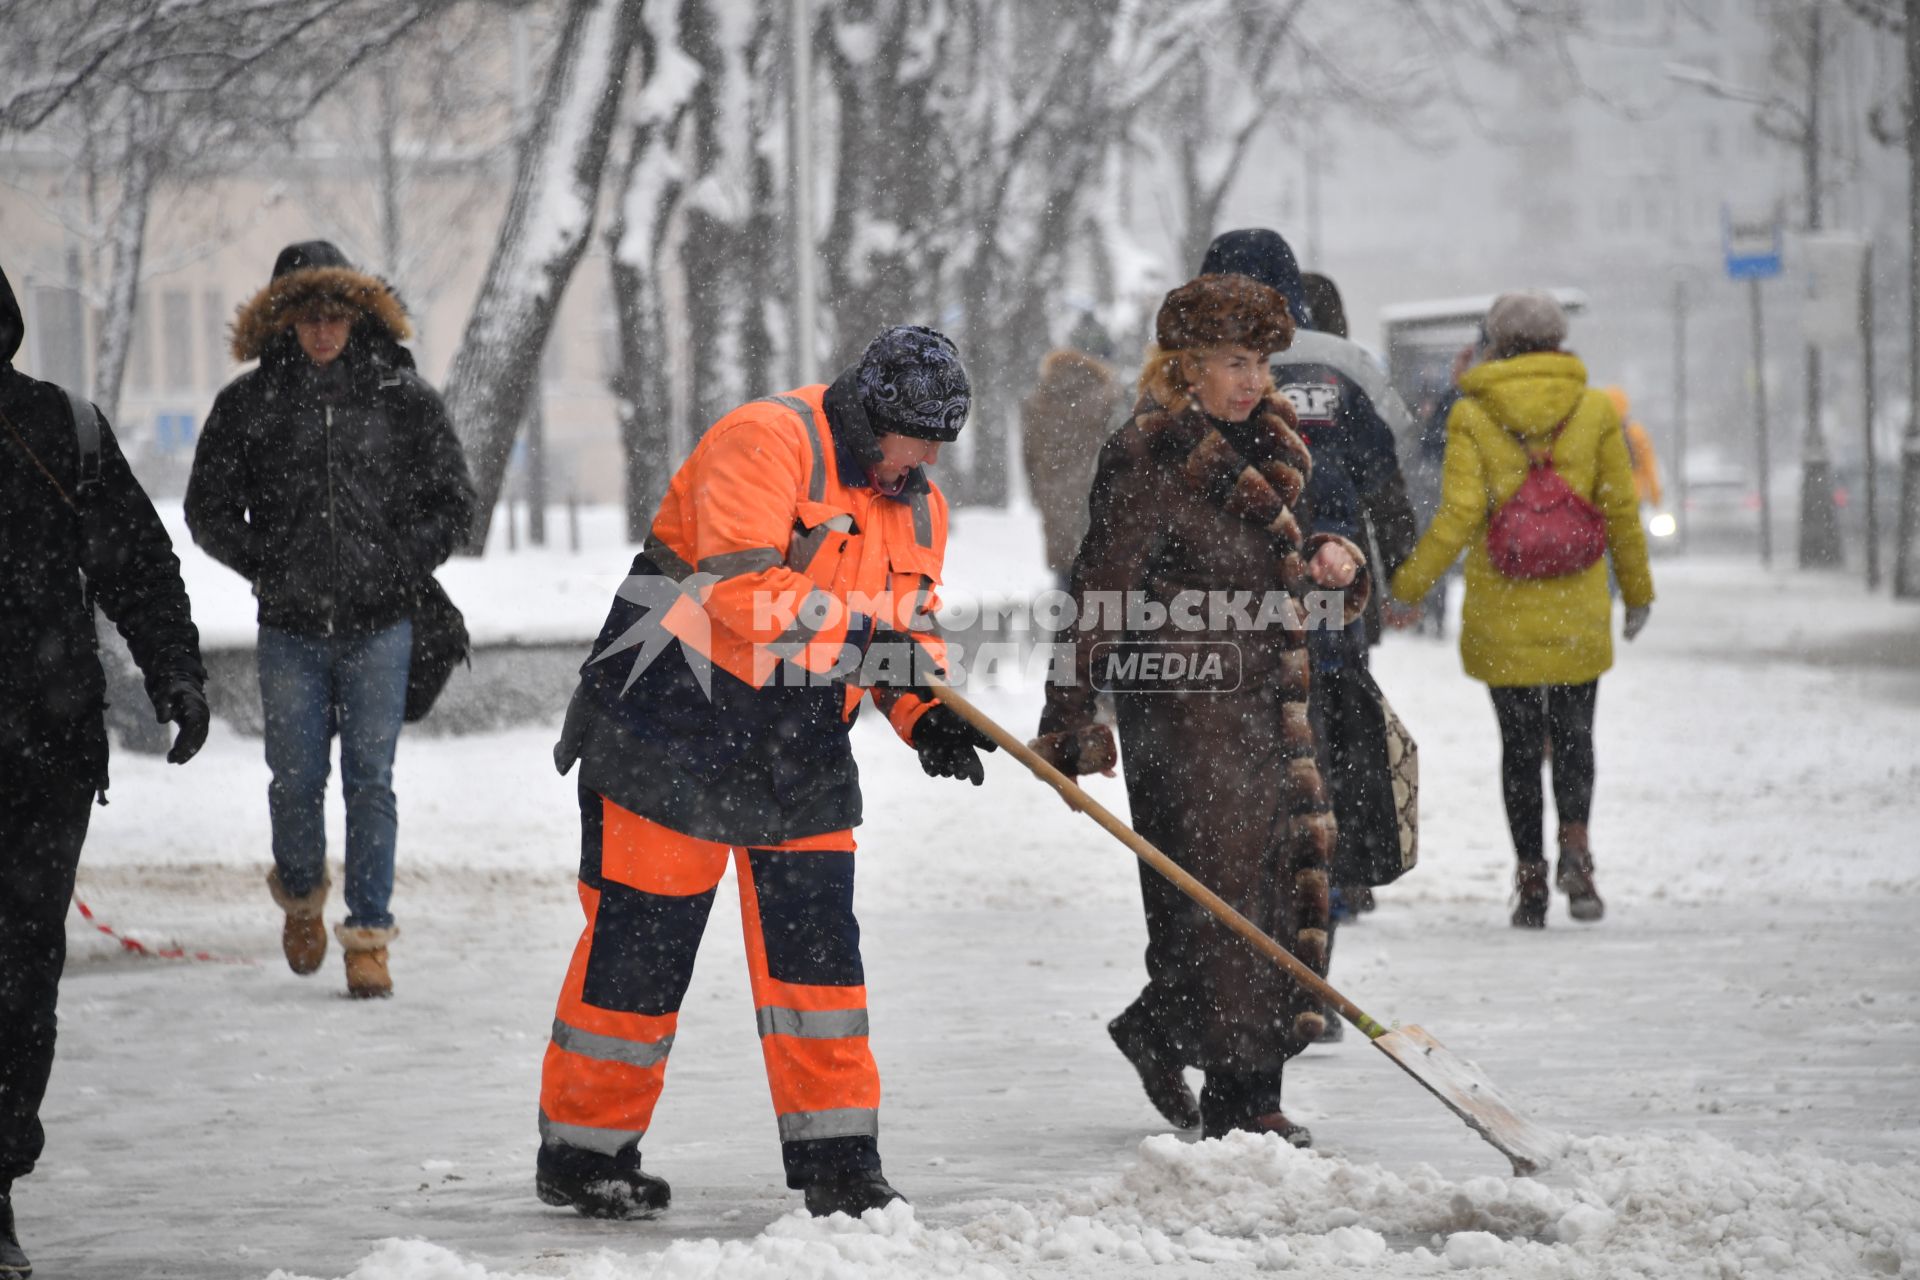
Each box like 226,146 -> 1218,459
30,512 -> 1920,1280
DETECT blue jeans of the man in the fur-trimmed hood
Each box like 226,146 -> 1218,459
255,620 -> 413,929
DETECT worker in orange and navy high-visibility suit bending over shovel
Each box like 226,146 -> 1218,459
536,326 -> 993,1217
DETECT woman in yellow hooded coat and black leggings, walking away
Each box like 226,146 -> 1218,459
1392,294 -> 1653,929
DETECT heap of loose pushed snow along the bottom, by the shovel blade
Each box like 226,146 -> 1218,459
269,1134 -> 1920,1280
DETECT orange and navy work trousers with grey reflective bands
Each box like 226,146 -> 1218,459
540,787 -> 879,1188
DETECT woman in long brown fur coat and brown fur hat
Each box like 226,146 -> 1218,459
1035,276 -> 1367,1146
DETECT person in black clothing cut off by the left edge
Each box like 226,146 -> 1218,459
0,260 -> 207,1276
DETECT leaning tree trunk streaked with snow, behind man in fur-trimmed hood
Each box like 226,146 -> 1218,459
447,0 -> 641,555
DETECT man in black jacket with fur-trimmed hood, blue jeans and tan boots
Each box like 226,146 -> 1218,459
186,240 -> 472,996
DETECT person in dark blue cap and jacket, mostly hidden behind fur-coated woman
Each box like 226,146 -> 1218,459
1202,228 -> 1419,1040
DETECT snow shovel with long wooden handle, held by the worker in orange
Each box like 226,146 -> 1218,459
927,677 -> 1565,1176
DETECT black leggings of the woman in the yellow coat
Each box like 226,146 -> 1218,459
1490,679 -> 1599,862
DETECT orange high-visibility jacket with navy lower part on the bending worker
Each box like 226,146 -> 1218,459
557,386 -> 947,844
